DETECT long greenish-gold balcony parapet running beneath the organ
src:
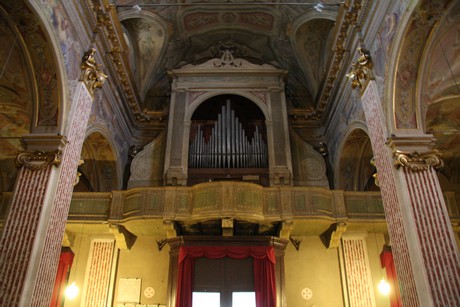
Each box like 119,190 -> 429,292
0,182 -> 460,225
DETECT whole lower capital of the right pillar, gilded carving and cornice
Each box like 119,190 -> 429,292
386,135 -> 444,172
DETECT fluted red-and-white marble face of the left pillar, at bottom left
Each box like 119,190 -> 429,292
0,144 -> 60,306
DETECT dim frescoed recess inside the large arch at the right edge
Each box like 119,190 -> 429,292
417,2 -> 460,191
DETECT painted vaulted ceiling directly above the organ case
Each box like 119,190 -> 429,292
115,1 -> 340,111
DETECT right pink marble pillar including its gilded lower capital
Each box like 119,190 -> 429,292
362,81 -> 460,306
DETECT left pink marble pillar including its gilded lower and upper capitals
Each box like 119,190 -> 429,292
0,49 -> 106,306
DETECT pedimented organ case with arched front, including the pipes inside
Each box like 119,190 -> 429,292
164,55 -> 292,186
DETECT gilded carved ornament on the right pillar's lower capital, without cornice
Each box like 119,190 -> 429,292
393,149 -> 444,172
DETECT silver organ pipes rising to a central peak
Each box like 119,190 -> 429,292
188,100 -> 268,168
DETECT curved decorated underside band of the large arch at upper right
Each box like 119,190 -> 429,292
384,0 -> 449,134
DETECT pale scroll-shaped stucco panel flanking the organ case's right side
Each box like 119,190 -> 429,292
290,131 -> 329,187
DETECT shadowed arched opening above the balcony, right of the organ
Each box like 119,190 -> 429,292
334,123 -> 378,191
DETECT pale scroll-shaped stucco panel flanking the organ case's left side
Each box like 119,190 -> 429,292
128,133 -> 166,188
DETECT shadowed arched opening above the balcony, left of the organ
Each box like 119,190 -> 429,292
74,127 -> 122,192
